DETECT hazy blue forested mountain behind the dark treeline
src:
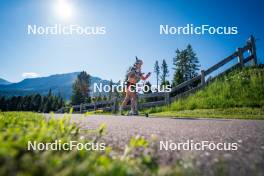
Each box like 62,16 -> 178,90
0,72 -> 109,100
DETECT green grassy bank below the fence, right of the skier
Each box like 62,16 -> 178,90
146,66 -> 264,119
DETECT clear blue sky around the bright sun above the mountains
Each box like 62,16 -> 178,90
0,0 -> 264,82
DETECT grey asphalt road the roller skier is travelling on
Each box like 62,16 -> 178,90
46,114 -> 264,175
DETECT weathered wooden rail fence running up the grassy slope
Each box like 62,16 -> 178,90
57,35 -> 257,113
